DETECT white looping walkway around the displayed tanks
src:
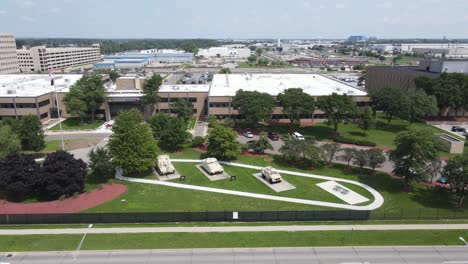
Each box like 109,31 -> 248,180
115,159 -> 384,210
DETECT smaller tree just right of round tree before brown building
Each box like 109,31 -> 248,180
408,89 -> 439,124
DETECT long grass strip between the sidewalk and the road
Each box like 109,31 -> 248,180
0,230 -> 468,252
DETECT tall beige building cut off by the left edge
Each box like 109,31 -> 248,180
0,32 -> 20,74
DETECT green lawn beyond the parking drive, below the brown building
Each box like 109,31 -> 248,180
264,113 -> 463,151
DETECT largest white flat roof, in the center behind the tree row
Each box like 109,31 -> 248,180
210,74 -> 367,96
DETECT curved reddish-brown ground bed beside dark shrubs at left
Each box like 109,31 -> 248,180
0,183 -> 127,214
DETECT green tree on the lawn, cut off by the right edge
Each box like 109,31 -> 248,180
443,155 -> 468,207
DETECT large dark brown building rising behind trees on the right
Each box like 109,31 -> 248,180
366,60 -> 468,91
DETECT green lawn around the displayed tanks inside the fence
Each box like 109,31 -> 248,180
88,149 -> 468,219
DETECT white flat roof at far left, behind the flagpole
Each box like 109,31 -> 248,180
0,74 -> 82,97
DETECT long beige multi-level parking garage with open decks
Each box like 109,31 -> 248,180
16,44 -> 101,73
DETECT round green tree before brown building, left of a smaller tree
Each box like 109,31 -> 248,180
370,87 -> 409,124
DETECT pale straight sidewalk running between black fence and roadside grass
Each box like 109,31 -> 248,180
0,224 -> 468,236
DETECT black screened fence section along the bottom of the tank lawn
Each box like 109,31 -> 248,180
0,210 -> 370,225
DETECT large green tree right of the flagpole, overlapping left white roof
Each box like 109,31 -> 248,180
63,74 -> 106,122
